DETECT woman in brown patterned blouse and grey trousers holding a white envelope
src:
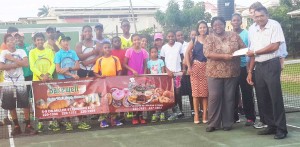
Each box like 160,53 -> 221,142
203,17 -> 245,132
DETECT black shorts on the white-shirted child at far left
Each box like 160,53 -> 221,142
1,86 -> 29,110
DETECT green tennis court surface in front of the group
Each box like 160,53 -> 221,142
0,113 -> 300,147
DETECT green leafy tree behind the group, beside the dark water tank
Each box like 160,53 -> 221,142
155,0 -> 211,36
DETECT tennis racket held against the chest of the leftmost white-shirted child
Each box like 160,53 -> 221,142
5,54 -> 22,98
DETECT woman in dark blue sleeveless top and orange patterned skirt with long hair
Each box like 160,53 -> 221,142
185,21 -> 208,124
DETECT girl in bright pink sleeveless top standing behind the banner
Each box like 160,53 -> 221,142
124,34 -> 148,125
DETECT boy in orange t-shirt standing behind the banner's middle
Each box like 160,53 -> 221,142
94,42 -> 123,128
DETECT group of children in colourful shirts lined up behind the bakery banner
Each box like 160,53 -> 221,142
0,20 -> 196,135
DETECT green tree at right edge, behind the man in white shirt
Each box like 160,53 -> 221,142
268,0 -> 300,58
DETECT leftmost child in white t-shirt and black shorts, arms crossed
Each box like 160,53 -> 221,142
0,34 -> 36,136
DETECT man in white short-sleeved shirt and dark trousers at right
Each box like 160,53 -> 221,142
247,7 -> 288,139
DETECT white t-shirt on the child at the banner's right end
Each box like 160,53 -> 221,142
160,42 -> 182,72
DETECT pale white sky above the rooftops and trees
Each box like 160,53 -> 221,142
0,0 -> 266,21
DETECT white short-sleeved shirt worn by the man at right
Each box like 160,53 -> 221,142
249,19 -> 285,62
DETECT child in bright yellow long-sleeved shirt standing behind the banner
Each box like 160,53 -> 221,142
29,33 -> 60,133
